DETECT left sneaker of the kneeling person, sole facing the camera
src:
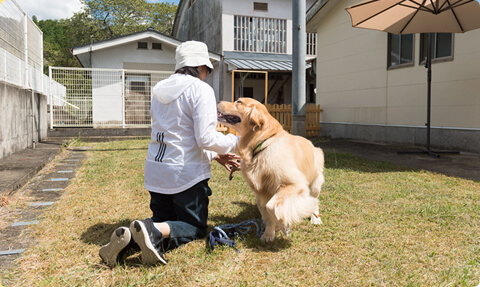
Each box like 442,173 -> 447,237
98,227 -> 132,268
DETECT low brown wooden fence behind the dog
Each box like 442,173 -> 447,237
217,104 -> 322,137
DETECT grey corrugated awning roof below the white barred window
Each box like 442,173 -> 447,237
225,51 -> 311,71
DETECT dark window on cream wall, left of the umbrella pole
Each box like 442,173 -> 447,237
388,33 -> 414,68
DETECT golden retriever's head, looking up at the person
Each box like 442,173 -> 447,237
217,98 -> 271,135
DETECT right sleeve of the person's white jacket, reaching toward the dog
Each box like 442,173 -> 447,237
193,82 -> 239,154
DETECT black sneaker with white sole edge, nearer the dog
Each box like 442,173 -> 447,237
130,218 -> 167,264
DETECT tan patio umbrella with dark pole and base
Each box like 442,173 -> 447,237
346,0 -> 480,157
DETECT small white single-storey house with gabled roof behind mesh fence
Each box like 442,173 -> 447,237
71,28 -> 220,127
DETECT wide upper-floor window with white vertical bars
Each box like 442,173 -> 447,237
233,15 -> 287,54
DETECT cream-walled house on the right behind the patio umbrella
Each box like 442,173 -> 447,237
307,0 -> 480,152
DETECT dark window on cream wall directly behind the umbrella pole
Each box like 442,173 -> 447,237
420,33 -> 453,63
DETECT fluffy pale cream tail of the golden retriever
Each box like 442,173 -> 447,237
267,190 -> 319,226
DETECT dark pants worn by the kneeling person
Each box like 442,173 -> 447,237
150,179 -> 212,250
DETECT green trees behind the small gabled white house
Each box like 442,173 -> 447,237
36,0 -> 177,72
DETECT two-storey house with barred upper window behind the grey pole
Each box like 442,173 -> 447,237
172,0 -> 316,104
